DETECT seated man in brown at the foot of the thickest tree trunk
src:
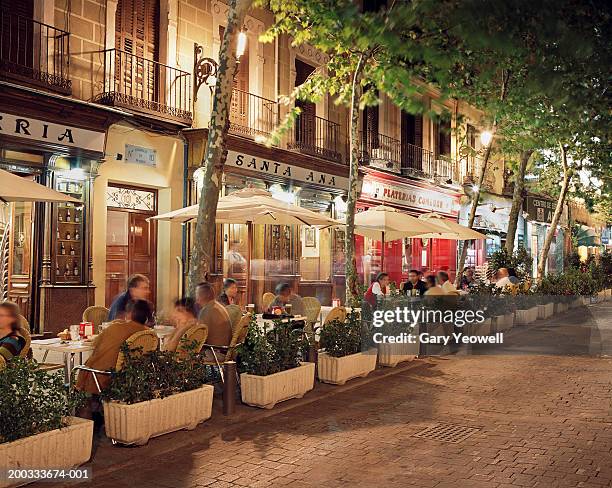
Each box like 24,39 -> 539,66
195,282 -> 232,346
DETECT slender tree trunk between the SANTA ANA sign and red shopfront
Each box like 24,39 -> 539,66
344,55 -> 365,305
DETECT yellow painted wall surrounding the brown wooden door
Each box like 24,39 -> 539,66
93,124 -> 183,310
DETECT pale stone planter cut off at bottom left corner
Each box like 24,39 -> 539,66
0,417 -> 93,488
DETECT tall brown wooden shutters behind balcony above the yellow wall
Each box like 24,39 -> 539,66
115,0 -> 158,101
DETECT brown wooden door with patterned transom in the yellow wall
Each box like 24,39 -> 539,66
105,187 -> 157,307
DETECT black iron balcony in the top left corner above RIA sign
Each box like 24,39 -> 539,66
0,9 -> 72,95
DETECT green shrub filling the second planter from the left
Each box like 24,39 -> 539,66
102,341 -> 210,404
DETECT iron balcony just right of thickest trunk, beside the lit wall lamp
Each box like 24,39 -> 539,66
229,88 -> 278,137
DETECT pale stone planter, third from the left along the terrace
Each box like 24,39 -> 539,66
240,363 -> 315,408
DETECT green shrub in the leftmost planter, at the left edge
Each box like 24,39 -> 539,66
0,358 -> 85,443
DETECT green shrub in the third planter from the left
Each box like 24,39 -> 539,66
238,319 -> 310,376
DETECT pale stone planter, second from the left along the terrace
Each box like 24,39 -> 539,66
104,385 -> 214,446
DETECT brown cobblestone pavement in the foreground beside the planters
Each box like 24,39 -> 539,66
76,304 -> 612,488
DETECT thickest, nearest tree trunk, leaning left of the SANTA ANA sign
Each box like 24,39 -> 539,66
189,0 -> 253,296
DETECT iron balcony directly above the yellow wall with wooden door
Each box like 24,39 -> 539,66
95,49 -> 192,125
